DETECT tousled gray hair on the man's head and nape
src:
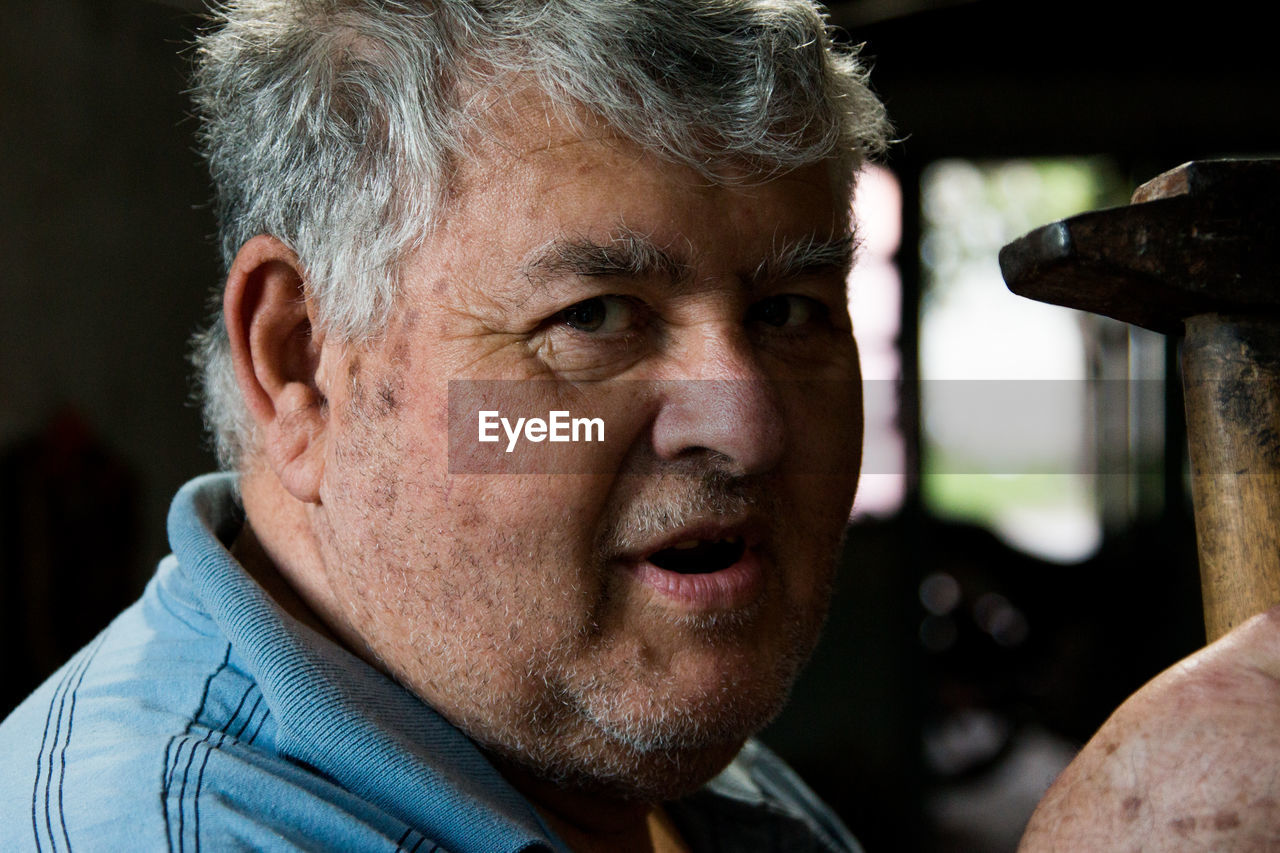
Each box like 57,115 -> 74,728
193,0 -> 887,467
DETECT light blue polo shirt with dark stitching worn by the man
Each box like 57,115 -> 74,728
0,475 -> 858,853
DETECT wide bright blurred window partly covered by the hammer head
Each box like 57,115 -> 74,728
920,159 -> 1128,562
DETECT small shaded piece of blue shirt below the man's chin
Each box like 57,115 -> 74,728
668,740 -> 861,853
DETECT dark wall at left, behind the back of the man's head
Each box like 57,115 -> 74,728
0,0 -> 218,704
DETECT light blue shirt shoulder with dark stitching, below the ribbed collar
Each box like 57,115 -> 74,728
0,566 -> 419,850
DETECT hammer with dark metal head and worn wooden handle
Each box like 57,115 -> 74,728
1000,160 -> 1280,640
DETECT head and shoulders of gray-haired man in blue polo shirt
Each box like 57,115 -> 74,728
0,0 -> 884,852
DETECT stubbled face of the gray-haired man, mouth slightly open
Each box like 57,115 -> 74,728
315,94 -> 861,799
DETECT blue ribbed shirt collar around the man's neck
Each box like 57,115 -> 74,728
169,474 -> 567,852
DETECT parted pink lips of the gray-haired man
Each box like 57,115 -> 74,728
623,514 -> 764,611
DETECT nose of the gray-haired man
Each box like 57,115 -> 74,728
653,326 -> 787,475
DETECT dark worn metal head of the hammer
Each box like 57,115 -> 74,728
1000,160 -> 1280,333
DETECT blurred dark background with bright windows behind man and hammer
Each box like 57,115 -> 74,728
0,0 -> 1280,852
